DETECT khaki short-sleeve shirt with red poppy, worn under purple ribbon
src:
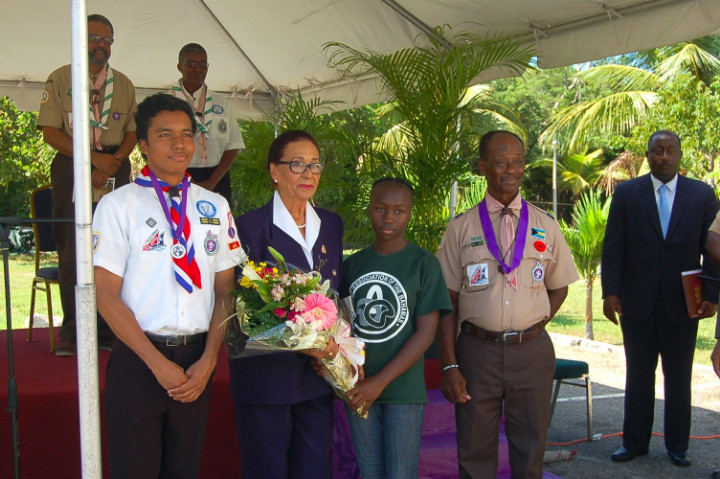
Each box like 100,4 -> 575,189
437,197 -> 579,332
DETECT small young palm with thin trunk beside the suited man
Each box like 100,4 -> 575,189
560,190 -> 610,339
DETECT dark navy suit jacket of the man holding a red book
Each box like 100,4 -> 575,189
601,174 -> 720,321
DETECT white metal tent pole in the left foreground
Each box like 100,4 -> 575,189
71,0 -> 102,479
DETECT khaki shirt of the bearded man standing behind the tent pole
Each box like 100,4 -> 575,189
37,65 -> 137,146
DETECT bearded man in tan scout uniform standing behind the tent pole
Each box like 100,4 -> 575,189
38,15 -> 137,356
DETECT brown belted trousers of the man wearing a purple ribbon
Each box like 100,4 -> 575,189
455,330 -> 555,479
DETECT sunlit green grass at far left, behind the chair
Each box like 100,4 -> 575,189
0,255 -> 62,330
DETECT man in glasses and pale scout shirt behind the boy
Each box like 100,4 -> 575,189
169,43 -> 245,208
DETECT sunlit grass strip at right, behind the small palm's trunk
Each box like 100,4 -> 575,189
548,279 -> 715,365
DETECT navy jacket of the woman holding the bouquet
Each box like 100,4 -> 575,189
230,200 -> 343,404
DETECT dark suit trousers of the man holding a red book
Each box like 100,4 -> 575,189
620,301 -> 698,454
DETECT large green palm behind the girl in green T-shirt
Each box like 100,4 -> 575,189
325,27 -> 532,251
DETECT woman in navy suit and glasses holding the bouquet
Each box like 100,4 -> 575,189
230,130 -> 343,479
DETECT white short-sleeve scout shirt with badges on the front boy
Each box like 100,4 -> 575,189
93,183 -> 243,334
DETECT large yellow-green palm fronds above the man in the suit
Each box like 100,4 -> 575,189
540,37 -> 720,156
